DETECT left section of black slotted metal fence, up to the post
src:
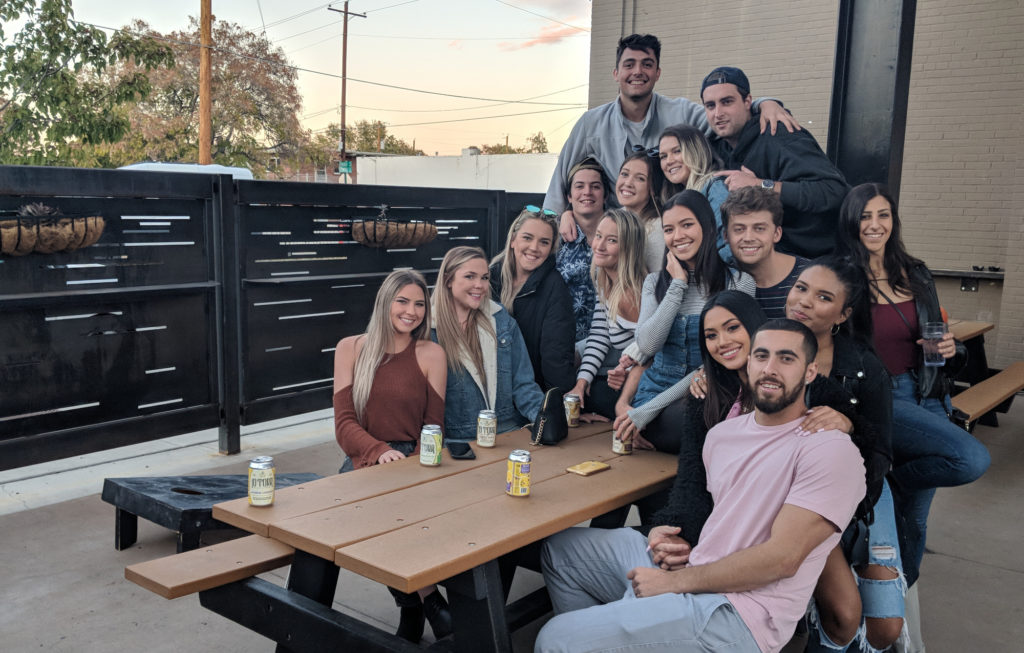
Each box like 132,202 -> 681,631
0,167 -> 219,468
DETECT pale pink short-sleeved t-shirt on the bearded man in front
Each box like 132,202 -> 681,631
690,412 -> 865,652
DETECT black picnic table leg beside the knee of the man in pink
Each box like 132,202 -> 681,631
444,560 -> 512,653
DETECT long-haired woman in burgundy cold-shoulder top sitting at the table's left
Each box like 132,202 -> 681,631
334,270 -> 452,642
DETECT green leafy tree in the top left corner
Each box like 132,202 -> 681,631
0,0 -> 173,165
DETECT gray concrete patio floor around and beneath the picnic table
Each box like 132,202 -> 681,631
0,398 -> 1024,653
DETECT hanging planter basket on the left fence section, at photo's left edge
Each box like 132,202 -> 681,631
0,204 -> 106,256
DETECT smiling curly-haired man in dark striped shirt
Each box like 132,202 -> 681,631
722,186 -> 810,319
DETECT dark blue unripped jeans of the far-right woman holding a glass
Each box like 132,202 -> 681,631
890,374 -> 991,584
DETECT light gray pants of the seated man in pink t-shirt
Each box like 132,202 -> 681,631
534,528 -> 759,653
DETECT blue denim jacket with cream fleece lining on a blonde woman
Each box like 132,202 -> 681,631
430,302 -> 544,440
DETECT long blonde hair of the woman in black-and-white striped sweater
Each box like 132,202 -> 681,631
590,209 -> 647,322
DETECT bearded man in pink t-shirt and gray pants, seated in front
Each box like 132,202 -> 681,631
536,319 -> 865,652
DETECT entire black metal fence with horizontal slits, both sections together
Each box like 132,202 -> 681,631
0,167 -> 543,469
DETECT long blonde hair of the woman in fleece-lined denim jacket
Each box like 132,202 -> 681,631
431,245 -> 495,387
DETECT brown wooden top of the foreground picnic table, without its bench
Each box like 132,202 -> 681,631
213,424 -> 676,592
